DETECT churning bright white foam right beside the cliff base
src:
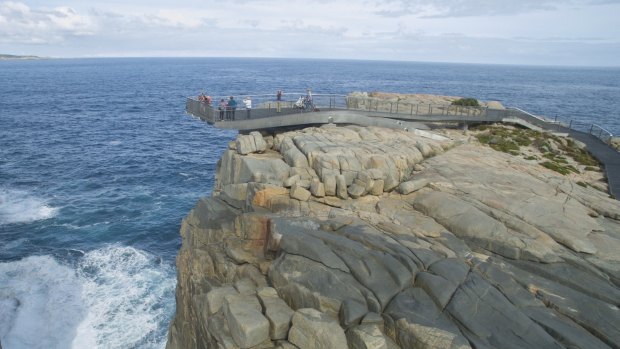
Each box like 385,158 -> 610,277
73,247 -> 175,348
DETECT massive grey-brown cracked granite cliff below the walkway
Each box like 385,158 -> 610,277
167,126 -> 620,349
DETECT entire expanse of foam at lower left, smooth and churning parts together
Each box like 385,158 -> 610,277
0,246 -> 175,349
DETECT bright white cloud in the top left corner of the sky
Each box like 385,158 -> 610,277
0,1 -> 97,44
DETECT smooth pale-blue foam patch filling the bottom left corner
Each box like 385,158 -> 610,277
0,256 -> 86,349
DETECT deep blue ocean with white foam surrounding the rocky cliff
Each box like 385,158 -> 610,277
0,58 -> 620,349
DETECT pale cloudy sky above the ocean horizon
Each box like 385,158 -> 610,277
0,0 -> 620,66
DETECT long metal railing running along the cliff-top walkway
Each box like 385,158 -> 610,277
186,92 -> 614,144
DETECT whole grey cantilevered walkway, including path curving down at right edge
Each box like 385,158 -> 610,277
186,93 -> 620,198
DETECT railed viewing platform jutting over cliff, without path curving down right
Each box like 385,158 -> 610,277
186,93 -> 568,131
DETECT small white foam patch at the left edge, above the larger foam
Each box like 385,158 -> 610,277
0,189 -> 58,224
